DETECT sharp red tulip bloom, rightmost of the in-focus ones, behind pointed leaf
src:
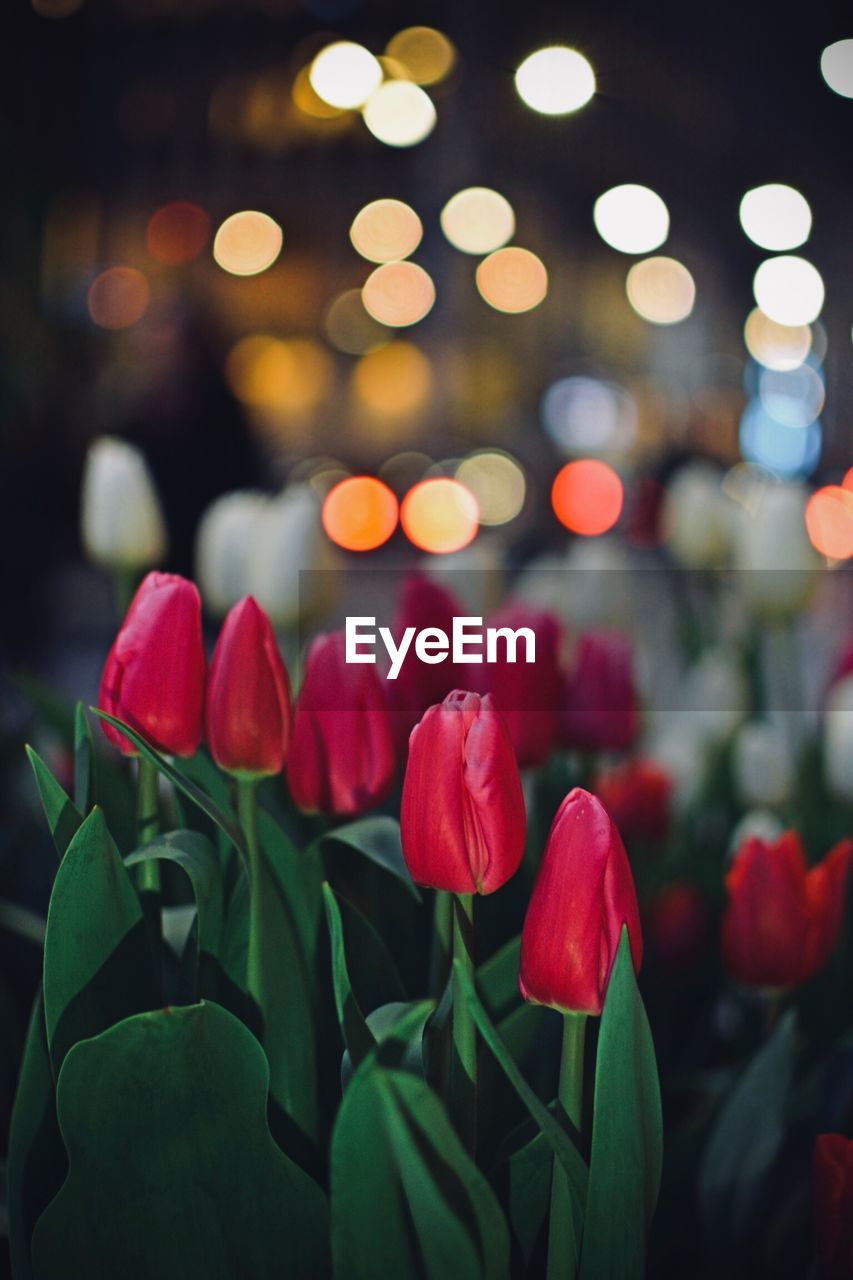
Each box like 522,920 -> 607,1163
519,787 -> 643,1014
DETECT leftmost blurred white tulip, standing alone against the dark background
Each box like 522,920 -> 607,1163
81,435 -> 167,570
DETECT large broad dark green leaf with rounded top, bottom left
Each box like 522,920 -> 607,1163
32,1004 -> 328,1280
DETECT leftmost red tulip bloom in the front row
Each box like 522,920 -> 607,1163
97,573 -> 207,755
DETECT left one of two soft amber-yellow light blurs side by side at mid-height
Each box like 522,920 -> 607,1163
225,334 -> 333,416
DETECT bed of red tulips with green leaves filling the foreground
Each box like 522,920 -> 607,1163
8,573 -> 853,1280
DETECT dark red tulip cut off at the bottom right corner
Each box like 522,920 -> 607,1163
812,1133 -> 853,1280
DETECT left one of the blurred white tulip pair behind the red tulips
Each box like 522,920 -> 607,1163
196,489 -> 272,616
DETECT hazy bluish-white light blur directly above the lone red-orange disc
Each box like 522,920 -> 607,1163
539,375 -> 637,454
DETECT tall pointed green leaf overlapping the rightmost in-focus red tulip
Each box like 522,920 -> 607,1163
580,927 -> 663,1280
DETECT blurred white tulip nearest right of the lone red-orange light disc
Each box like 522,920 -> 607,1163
661,462 -> 731,568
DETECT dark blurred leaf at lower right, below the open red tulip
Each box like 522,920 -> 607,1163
698,1010 -> 797,1245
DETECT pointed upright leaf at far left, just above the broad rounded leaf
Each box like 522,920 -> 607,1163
44,808 -> 159,1073
